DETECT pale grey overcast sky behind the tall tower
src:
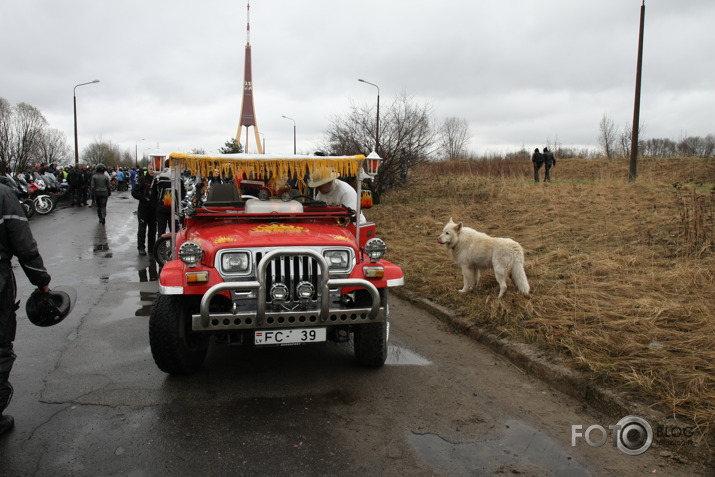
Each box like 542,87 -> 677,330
0,0 -> 715,156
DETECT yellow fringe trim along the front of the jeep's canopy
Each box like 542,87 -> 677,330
169,152 -> 365,187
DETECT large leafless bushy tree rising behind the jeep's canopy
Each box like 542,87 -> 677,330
321,93 -> 437,201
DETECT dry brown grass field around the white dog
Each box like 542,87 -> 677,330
366,155 -> 715,433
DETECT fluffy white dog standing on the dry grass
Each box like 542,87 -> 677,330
437,218 -> 529,298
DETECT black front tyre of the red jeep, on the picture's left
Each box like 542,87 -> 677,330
149,295 -> 209,375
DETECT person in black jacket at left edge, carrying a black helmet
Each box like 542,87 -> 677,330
0,184 -> 50,434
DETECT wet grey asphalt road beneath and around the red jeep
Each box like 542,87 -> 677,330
0,192 -> 705,477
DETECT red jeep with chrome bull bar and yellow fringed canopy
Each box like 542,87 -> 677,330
149,153 -> 404,374
